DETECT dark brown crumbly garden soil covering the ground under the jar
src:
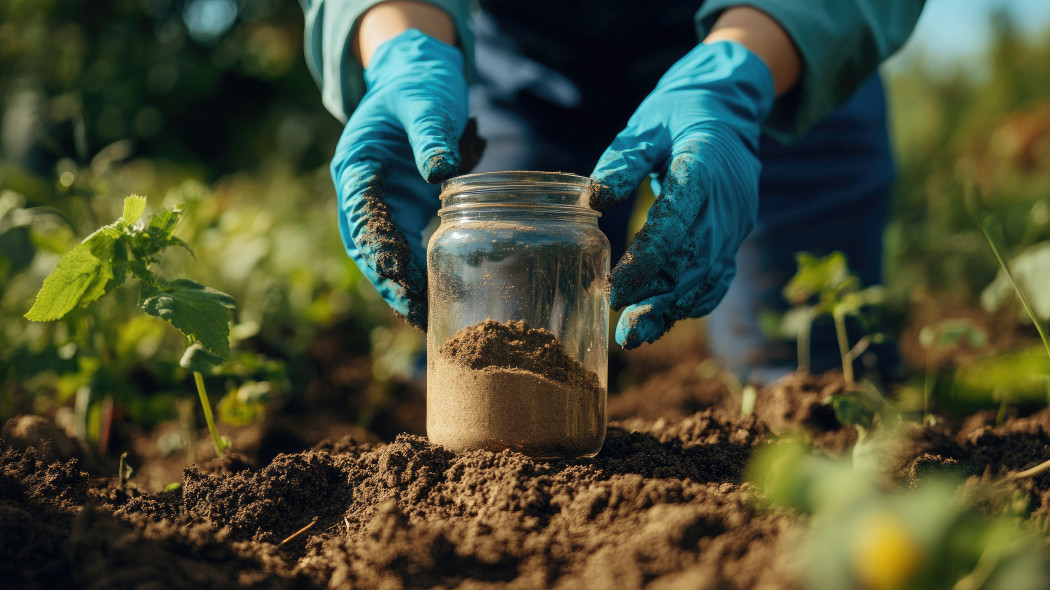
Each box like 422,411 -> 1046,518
6,327 -> 1050,589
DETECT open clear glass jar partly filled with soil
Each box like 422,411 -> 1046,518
426,172 -> 609,459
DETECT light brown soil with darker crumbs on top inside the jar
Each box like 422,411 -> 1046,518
426,319 -> 606,459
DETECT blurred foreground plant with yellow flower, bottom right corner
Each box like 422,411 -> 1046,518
749,441 -> 1050,590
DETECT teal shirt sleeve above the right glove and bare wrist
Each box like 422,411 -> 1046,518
696,0 -> 925,143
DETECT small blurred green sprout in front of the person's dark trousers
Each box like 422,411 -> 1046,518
782,251 -> 883,385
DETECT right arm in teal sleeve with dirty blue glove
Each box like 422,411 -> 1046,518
591,0 -> 919,350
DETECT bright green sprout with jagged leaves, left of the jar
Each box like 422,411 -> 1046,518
25,195 -> 235,456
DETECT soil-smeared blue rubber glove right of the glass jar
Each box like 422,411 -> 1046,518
591,41 -> 775,350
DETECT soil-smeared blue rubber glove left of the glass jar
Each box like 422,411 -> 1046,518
332,29 -> 467,330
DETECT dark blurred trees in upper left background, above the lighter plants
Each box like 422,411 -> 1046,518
0,0 -> 340,176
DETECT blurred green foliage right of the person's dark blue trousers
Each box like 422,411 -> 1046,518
886,10 -> 1050,307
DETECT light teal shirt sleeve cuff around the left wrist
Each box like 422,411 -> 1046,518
299,0 -> 475,123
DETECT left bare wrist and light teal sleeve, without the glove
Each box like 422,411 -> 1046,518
299,0 -> 474,123
